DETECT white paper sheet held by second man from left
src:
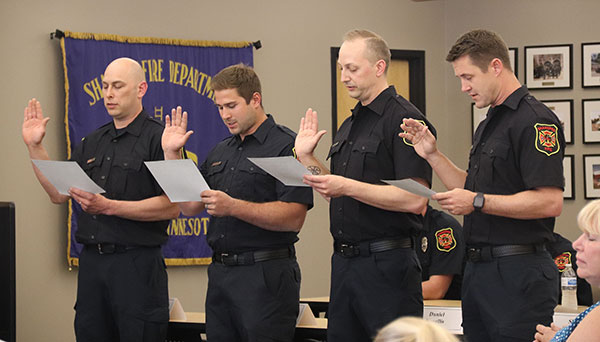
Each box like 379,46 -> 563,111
144,159 -> 210,203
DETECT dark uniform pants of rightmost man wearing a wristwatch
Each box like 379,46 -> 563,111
462,252 -> 558,342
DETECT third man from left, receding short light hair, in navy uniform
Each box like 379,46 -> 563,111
295,30 -> 433,342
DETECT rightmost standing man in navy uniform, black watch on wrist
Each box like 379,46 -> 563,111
400,30 -> 565,341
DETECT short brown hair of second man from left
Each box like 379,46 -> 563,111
210,63 -> 262,104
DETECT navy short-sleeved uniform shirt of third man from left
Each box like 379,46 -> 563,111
328,86 -> 435,243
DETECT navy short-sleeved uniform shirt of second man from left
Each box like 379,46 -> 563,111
200,115 -> 313,253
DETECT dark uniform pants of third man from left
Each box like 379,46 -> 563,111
327,248 -> 423,342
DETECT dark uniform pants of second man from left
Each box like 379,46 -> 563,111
206,258 -> 300,342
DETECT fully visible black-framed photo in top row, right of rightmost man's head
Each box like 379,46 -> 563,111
524,44 -> 573,90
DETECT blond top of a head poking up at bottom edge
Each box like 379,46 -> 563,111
374,317 -> 458,342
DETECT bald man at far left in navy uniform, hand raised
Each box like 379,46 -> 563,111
23,58 -> 179,342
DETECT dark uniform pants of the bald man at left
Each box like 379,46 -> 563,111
75,246 -> 169,342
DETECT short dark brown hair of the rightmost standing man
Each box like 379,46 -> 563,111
446,29 -> 513,72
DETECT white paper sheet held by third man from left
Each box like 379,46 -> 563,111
248,156 -> 310,186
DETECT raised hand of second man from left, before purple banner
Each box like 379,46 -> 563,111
161,106 -> 194,159
